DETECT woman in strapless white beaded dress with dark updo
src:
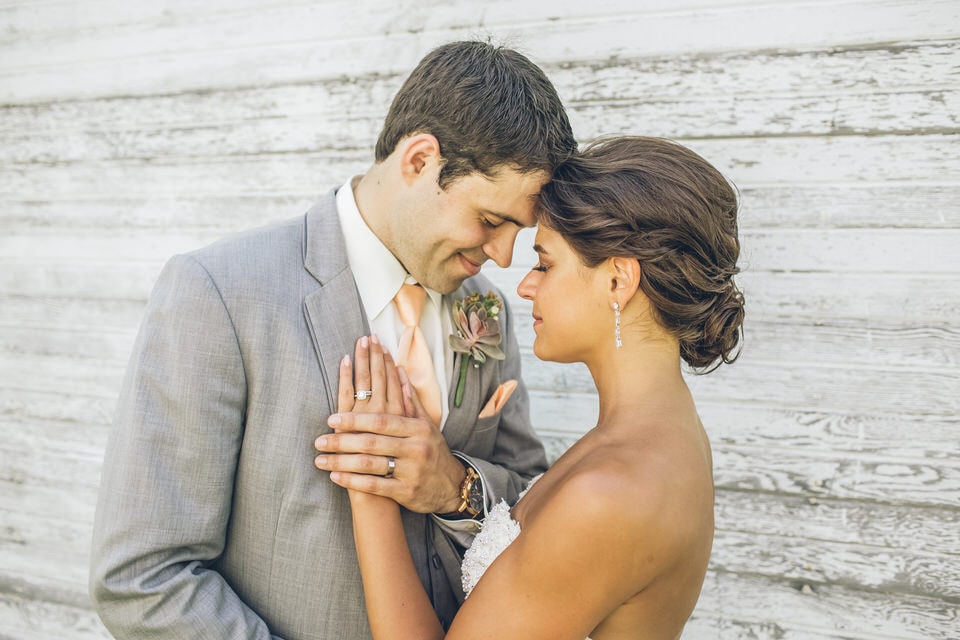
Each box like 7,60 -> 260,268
322,137 -> 744,640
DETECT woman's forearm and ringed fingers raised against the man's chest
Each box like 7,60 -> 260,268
330,338 -> 444,640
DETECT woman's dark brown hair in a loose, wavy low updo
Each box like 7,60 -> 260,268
538,137 -> 744,373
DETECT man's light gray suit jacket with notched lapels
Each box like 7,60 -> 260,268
90,192 -> 546,640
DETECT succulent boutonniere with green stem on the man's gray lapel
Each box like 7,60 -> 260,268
450,292 -> 504,407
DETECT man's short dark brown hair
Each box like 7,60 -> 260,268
376,41 -> 577,188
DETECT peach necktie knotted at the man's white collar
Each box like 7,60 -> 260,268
393,284 -> 443,426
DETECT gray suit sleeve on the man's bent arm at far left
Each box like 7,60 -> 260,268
90,256 -> 284,640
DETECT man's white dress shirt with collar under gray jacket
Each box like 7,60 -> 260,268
337,178 -> 453,429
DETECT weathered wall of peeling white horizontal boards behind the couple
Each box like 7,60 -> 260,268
0,0 -> 960,640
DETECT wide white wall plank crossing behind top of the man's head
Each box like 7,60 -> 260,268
0,0 -> 958,103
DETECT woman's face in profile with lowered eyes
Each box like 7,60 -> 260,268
517,225 -> 614,362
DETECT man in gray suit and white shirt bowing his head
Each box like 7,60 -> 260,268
91,42 -> 576,640
